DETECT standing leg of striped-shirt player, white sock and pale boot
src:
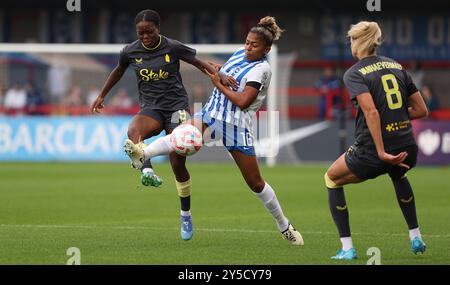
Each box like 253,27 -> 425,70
230,150 -> 304,245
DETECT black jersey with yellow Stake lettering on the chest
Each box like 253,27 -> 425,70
119,35 -> 196,111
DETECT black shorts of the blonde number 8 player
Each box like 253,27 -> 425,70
345,145 -> 417,180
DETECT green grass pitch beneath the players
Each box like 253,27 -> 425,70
0,163 -> 450,265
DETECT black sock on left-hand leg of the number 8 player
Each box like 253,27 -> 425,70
327,187 -> 350,238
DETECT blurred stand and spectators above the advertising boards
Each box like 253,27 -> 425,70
0,0 -> 450,120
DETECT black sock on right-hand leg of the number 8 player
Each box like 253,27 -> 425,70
392,177 -> 419,229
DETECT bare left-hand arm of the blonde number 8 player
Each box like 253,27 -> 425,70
356,92 -> 409,169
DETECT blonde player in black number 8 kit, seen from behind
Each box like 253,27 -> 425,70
325,21 -> 428,260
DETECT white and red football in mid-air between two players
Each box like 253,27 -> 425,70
170,124 -> 202,156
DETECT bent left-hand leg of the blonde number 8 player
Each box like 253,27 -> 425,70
324,154 -> 361,260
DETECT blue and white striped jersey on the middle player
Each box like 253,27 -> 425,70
203,48 -> 272,130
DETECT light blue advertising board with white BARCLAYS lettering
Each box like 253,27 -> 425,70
0,116 -> 165,162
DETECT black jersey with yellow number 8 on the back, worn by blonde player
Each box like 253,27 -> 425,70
344,56 -> 417,150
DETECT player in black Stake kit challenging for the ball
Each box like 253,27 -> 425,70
92,10 -> 215,240
